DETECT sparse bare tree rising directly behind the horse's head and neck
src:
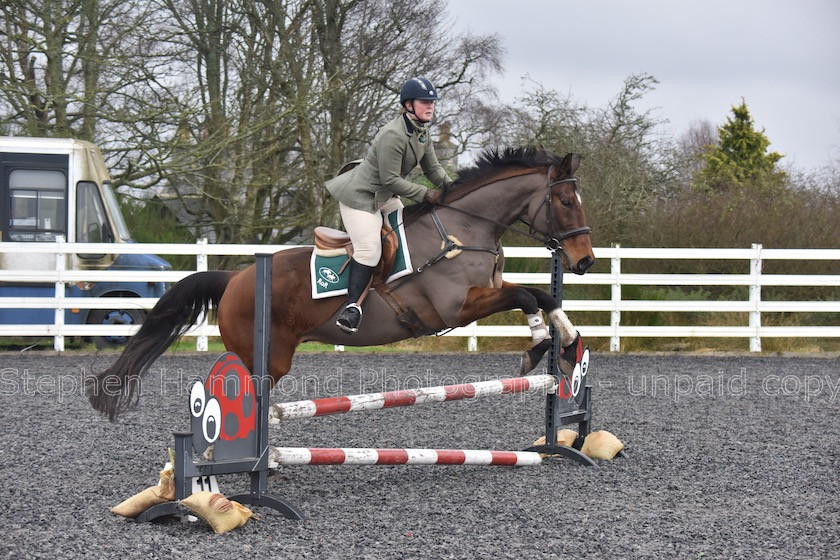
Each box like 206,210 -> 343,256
506,74 -> 679,242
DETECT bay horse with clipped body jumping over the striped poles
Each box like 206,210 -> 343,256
86,148 -> 595,420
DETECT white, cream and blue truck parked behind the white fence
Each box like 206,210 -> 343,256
0,137 -> 172,347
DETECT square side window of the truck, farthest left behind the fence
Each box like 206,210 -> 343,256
9,169 -> 67,241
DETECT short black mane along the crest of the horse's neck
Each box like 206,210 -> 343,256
406,146 -> 563,221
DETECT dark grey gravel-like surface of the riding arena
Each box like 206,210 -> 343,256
0,352 -> 840,560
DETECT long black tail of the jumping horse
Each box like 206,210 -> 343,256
86,270 -> 235,421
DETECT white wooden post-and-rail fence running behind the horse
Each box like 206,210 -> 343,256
0,240 -> 840,352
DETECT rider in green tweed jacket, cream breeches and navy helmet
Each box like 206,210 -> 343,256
326,77 -> 451,334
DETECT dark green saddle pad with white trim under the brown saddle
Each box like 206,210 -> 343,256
309,208 -> 413,299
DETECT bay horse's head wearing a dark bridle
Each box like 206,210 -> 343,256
528,154 -> 595,274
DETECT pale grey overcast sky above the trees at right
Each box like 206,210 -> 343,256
442,0 -> 840,170
